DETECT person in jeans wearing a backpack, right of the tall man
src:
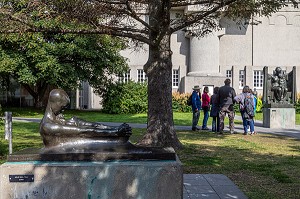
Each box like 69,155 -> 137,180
234,86 -> 255,135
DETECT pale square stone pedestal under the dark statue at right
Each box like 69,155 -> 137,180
263,108 -> 296,129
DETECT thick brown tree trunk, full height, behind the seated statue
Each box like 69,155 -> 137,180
139,0 -> 182,150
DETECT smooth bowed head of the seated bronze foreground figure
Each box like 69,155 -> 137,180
48,89 -> 70,115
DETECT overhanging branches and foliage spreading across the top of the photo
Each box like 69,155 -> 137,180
0,0 -> 297,40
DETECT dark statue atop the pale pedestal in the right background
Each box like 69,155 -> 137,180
263,67 -> 296,107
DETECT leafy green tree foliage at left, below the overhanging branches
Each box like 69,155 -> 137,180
0,33 -> 127,107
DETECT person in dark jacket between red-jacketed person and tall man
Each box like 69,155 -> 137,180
210,87 -> 220,132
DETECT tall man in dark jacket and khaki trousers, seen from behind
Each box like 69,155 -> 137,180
218,79 -> 236,134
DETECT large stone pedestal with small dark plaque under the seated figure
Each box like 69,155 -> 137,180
0,158 -> 183,199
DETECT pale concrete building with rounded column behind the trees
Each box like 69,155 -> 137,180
80,3 -> 300,108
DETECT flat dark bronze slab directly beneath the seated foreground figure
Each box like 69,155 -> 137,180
7,142 -> 176,162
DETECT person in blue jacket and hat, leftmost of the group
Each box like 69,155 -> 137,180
192,85 -> 201,131
